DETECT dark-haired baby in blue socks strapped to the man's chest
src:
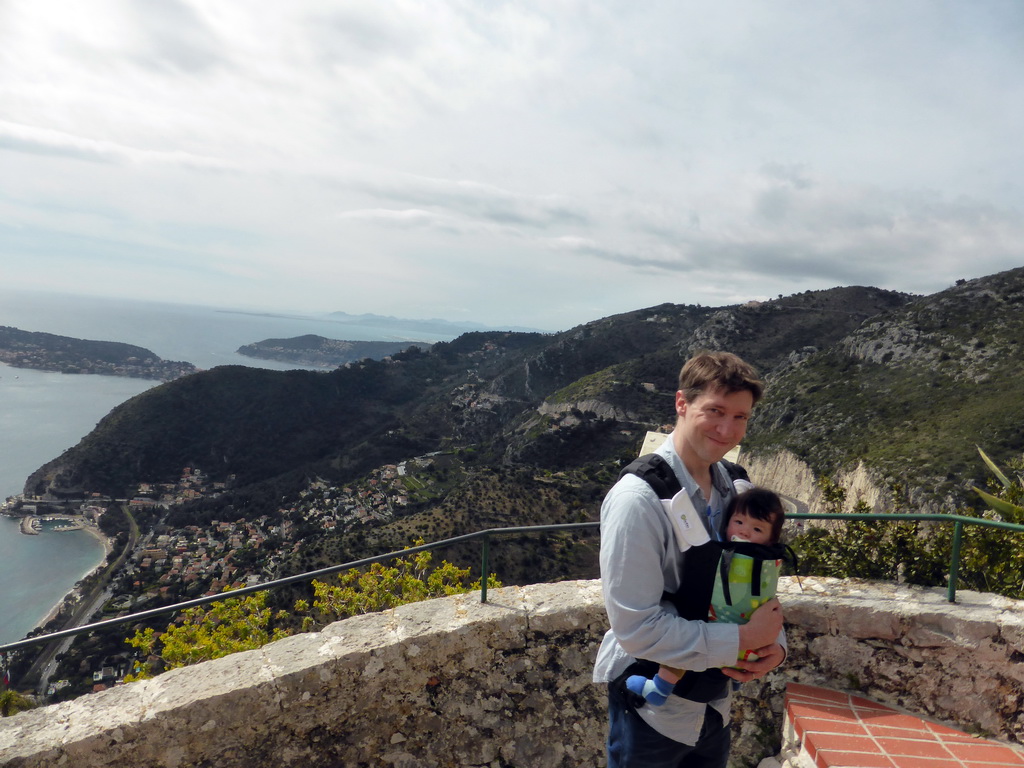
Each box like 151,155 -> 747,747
626,483 -> 785,707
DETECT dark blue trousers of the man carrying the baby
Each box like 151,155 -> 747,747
607,683 -> 730,768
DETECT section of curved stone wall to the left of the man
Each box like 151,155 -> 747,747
0,582 -> 605,768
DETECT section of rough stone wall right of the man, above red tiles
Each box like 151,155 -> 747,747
781,578 -> 1024,743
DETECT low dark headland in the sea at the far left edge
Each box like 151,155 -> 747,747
0,326 -> 199,381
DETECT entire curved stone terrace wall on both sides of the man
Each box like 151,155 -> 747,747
0,579 -> 1024,768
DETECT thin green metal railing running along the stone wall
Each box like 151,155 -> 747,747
0,512 -> 1024,654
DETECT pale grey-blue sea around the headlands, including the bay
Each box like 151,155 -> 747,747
0,290 -> 455,644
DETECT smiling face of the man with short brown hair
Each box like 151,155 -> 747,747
676,389 -> 754,471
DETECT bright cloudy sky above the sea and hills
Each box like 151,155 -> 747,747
0,0 -> 1024,331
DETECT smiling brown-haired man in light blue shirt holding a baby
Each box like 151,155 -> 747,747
594,352 -> 785,768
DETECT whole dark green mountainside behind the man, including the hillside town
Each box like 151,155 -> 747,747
14,269 -> 1024,704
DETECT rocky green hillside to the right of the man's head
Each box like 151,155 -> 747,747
745,269 -> 1024,509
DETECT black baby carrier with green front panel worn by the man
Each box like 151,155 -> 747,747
620,454 -> 786,705
